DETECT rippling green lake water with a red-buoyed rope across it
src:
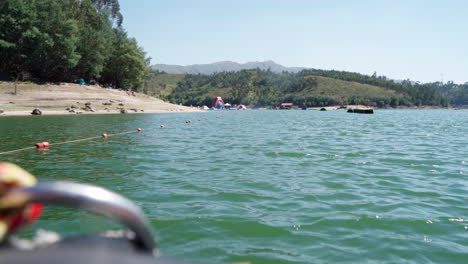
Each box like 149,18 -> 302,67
0,110 -> 468,263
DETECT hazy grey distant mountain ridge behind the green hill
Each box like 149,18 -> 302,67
152,60 -> 306,74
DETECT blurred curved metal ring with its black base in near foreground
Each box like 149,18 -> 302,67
0,182 -> 196,264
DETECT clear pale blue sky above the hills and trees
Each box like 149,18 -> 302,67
120,0 -> 468,83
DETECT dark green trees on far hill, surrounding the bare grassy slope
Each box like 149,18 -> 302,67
164,69 -> 449,107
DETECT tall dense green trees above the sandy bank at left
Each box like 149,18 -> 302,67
0,0 -> 149,90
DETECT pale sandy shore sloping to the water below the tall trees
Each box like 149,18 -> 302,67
0,82 -> 203,116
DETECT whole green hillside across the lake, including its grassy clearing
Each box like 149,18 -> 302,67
145,69 -> 447,107
